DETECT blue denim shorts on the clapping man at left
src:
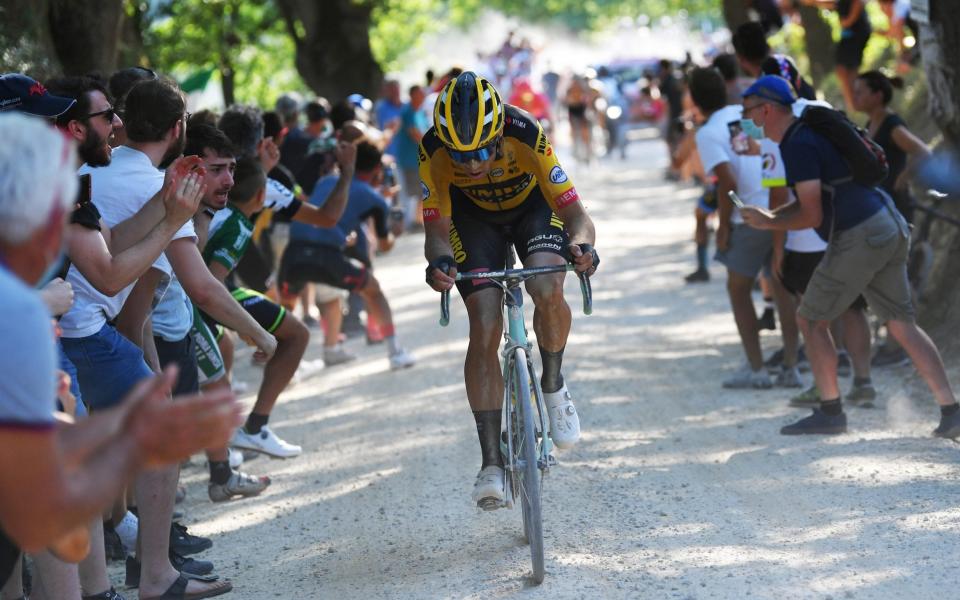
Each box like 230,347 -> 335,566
61,325 -> 153,411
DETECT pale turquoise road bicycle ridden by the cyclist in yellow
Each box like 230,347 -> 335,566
440,246 -> 593,584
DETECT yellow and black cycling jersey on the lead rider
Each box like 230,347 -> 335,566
420,104 -> 579,221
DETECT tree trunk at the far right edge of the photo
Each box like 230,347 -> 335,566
920,0 -> 960,338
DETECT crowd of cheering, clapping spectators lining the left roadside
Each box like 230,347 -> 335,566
0,57 -> 429,600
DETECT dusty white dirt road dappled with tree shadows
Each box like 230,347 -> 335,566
144,136 -> 960,600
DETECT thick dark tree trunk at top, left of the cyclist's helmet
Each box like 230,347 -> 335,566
277,0 -> 383,101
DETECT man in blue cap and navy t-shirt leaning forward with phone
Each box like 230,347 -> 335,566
741,75 -> 960,438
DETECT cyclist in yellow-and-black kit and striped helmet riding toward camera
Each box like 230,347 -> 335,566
420,71 -> 599,505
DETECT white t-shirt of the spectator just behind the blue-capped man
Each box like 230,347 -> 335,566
697,104 -> 770,223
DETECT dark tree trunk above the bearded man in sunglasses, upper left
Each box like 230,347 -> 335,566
48,0 -> 126,75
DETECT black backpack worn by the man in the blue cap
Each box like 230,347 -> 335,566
800,106 -> 890,187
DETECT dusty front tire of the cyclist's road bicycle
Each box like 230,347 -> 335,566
513,348 -> 545,584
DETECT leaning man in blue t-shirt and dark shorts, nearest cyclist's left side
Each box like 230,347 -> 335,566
280,142 -> 415,370
